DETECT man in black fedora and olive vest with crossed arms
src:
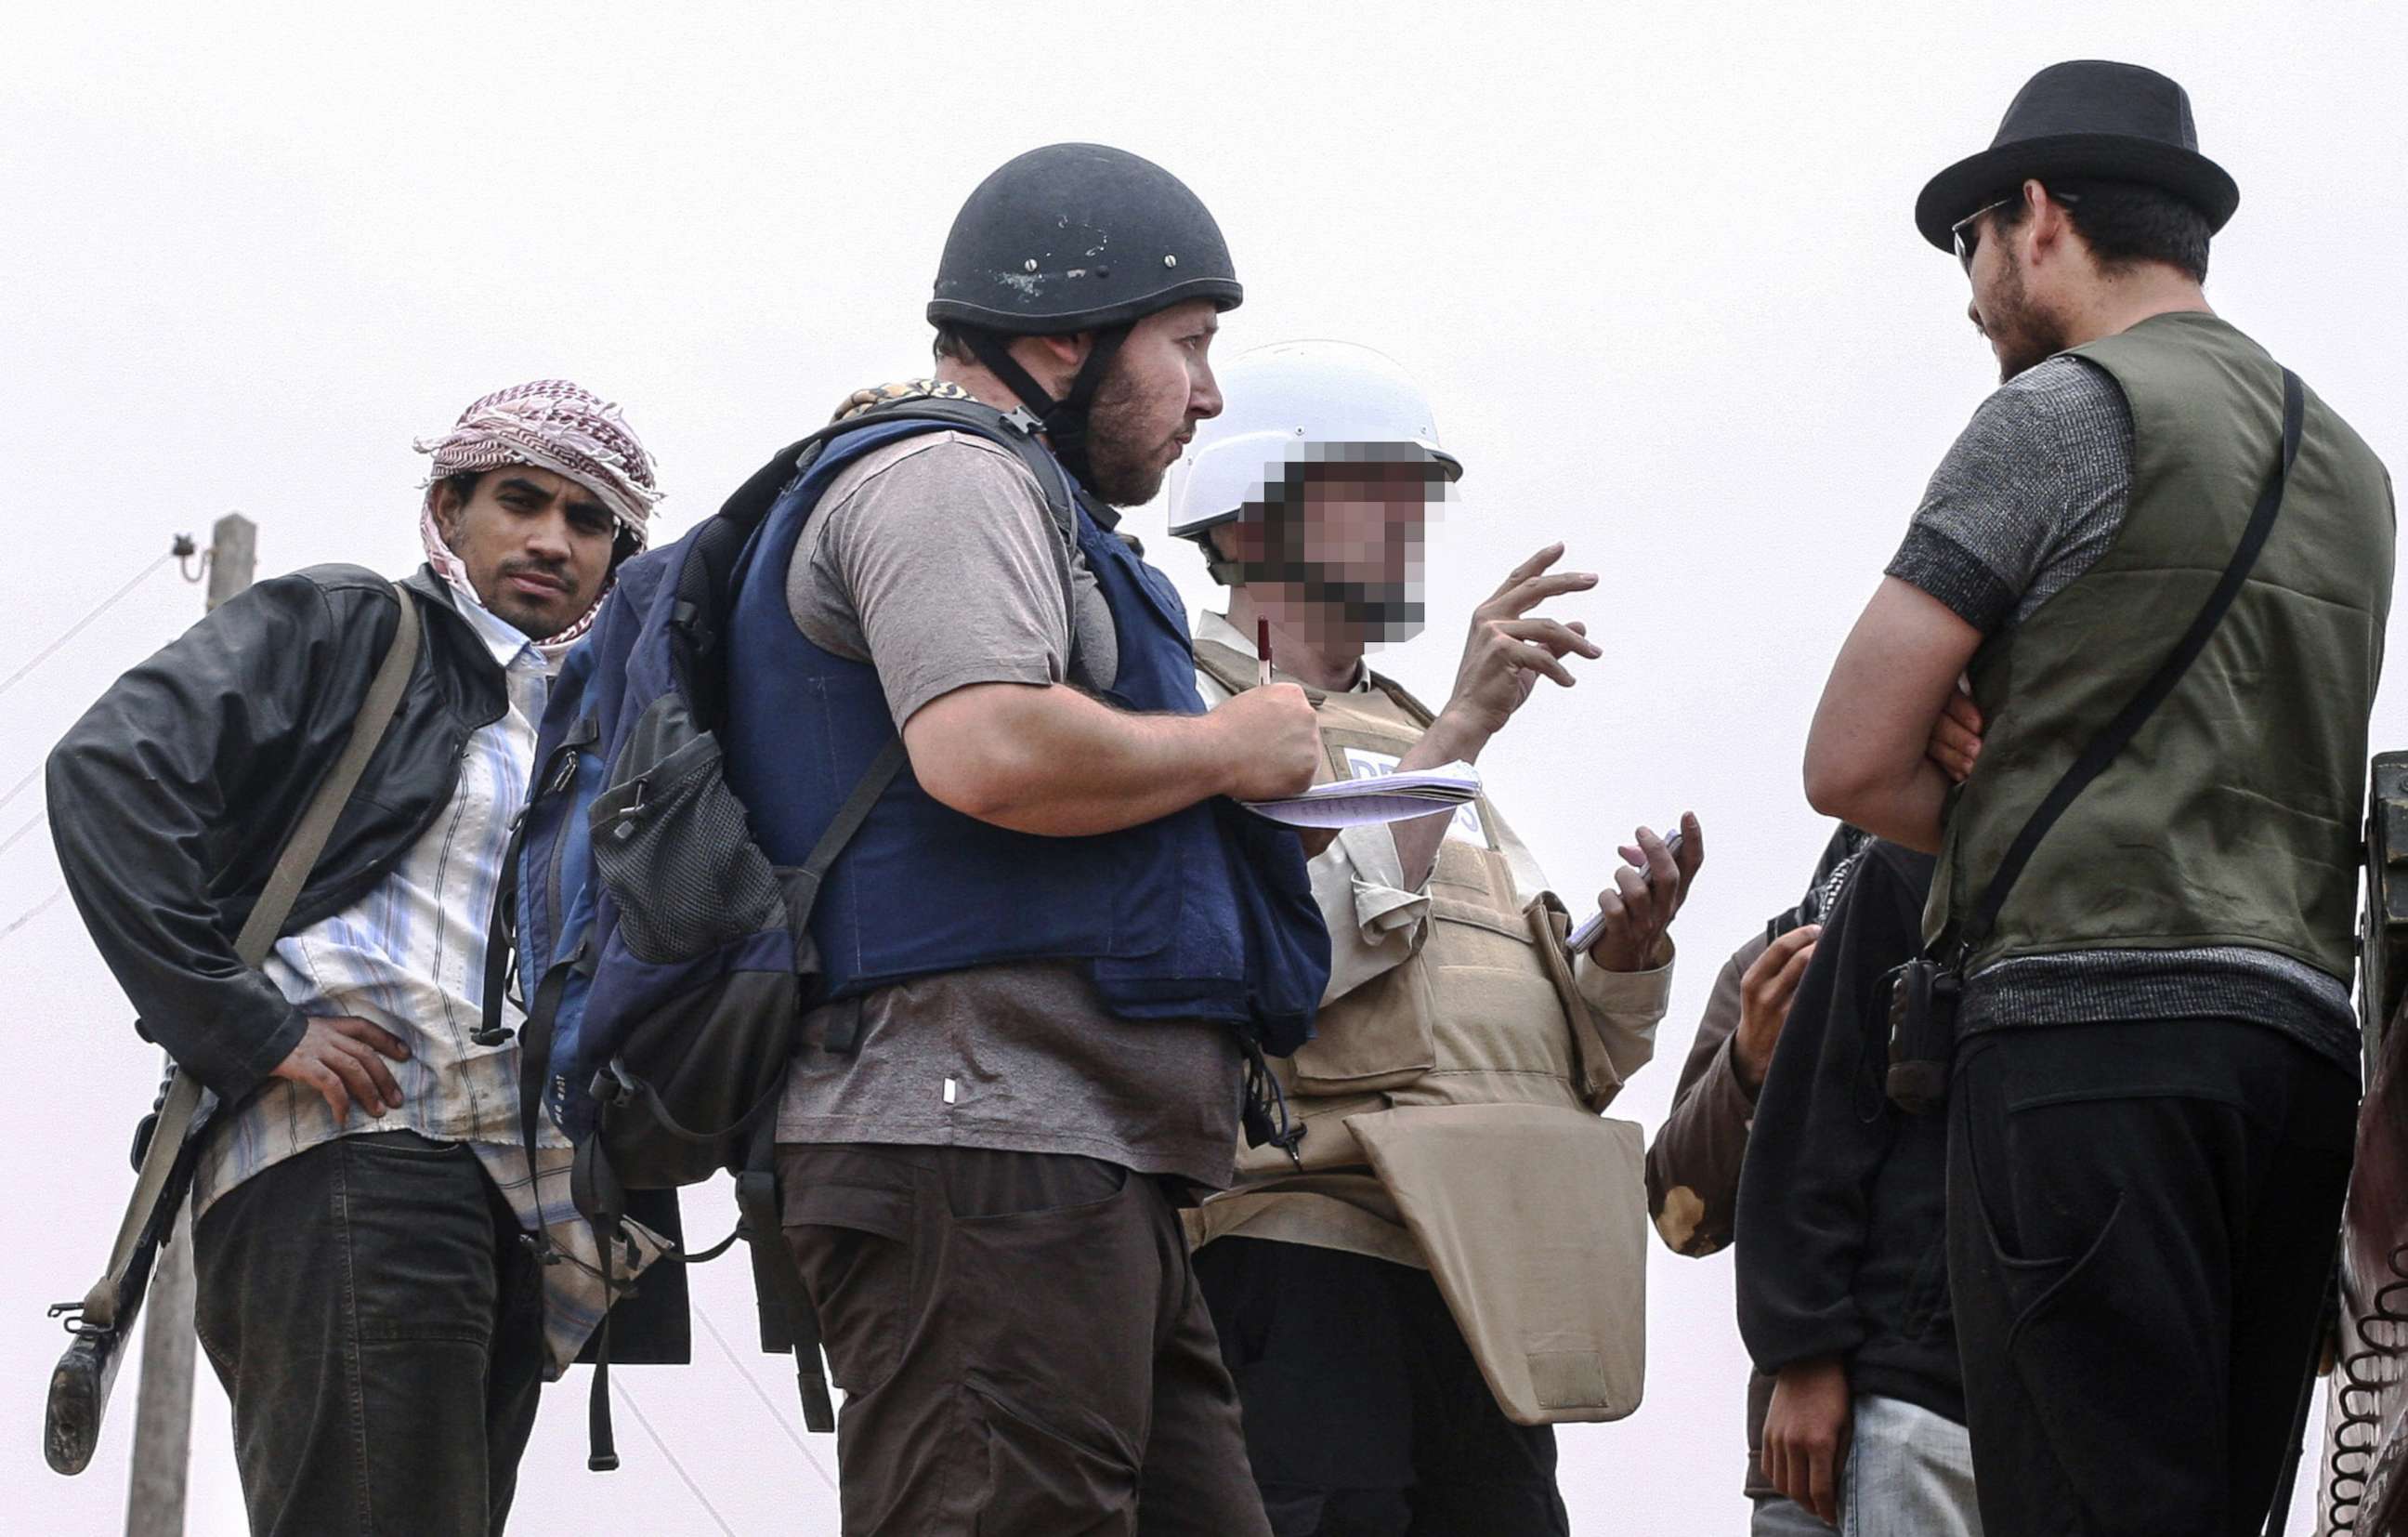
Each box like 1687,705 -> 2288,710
1806,60 -> 2393,1537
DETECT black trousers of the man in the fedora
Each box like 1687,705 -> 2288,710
1948,1019 -> 2358,1537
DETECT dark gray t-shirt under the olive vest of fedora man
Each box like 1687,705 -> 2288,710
1888,357 -> 2358,1070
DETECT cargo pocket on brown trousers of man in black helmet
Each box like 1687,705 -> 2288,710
963,1371 -> 1139,1537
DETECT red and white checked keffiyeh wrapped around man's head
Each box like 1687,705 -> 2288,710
412,378 -> 660,660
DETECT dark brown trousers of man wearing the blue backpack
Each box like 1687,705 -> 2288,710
778,1144 -> 1266,1537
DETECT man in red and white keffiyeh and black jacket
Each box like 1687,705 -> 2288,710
48,378 -> 684,1534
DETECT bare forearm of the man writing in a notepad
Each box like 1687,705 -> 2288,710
903,684 -> 1236,838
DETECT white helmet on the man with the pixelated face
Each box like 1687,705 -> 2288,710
1171,342 -> 1464,540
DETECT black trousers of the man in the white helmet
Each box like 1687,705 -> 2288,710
1197,1239 -> 1573,1537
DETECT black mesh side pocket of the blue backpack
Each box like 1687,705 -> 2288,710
587,696 -> 785,964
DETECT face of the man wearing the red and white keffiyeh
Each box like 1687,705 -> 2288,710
436,465 -> 619,641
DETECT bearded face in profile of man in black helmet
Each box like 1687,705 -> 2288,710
1086,298 -> 1221,506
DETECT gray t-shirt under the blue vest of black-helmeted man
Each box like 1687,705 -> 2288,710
778,431 -> 1240,1188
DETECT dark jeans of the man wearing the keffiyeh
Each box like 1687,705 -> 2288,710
192,1132 -> 544,1537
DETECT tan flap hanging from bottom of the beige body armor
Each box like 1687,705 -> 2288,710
1346,1106 -> 1647,1424
